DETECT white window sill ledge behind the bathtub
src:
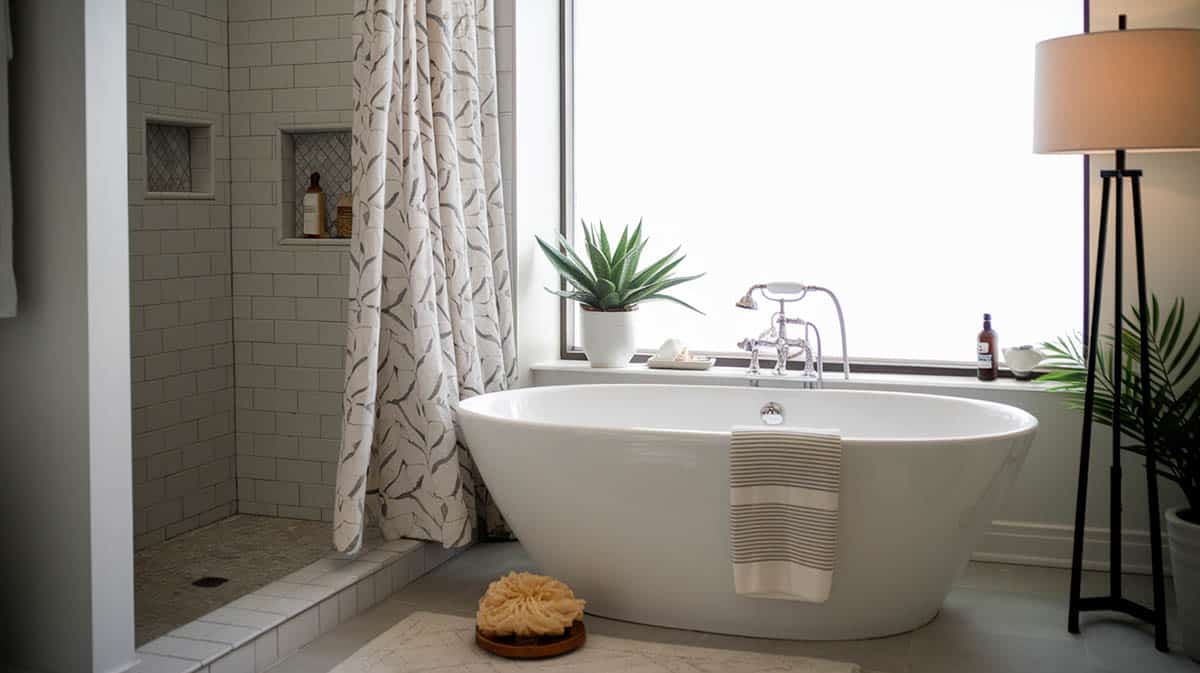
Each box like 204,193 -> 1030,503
530,360 -> 1049,395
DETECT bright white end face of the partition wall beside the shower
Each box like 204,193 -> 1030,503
82,0 -> 137,672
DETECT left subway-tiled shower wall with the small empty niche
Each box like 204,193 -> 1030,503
127,0 -> 236,548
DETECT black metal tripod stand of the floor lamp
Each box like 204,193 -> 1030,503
1067,14 -> 1168,651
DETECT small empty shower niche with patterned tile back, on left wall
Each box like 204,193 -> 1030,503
145,118 -> 214,199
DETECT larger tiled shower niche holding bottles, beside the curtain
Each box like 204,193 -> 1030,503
280,128 -> 350,241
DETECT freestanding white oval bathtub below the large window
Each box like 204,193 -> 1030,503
458,385 -> 1038,639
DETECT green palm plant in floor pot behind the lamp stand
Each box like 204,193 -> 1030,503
1039,298 -> 1200,660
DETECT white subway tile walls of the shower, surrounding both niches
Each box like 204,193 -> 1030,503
128,0 -> 515,542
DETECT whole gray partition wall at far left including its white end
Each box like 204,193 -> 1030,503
0,0 -> 133,673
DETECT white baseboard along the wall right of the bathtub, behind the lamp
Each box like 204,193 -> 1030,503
971,521 -> 1171,575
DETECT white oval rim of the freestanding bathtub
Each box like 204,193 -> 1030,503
455,383 -> 1038,446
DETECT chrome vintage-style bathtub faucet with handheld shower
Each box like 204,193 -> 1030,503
737,282 -> 850,387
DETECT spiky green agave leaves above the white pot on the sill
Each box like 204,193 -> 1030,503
538,220 -> 703,314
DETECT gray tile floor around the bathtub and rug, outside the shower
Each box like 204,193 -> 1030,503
271,542 -> 1200,673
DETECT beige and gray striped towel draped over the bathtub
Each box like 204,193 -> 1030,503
730,426 -> 841,603
